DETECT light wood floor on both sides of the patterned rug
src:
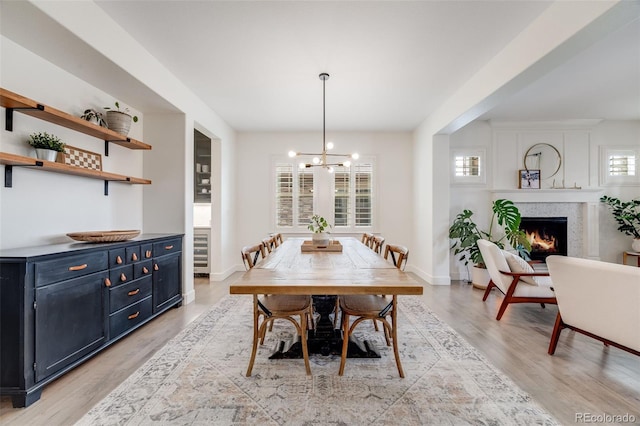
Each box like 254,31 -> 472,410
0,273 -> 640,426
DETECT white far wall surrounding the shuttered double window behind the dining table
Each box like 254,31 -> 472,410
236,132 -> 413,268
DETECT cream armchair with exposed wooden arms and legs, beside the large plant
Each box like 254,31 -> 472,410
477,240 -> 556,320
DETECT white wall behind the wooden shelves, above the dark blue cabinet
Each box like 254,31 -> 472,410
0,37 -> 145,248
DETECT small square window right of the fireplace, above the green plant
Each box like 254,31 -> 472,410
600,146 -> 640,186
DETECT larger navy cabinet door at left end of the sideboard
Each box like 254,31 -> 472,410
35,271 -> 107,382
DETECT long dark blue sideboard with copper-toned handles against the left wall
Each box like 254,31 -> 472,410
0,234 -> 182,407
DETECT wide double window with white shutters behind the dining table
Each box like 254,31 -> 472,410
273,159 -> 374,232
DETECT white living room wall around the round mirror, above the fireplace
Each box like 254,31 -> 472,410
449,120 -> 640,279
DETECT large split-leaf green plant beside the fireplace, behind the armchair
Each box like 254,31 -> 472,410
449,199 -> 531,267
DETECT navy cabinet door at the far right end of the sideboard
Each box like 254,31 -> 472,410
153,252 -> 182,314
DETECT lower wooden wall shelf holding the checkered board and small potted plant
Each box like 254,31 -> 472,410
0,152 -> 151,195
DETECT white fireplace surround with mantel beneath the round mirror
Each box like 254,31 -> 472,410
491,189 -> 602,260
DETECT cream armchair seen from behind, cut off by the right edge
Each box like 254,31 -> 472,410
547,256 -> 640,355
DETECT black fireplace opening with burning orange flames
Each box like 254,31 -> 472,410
520,217 -> 567,261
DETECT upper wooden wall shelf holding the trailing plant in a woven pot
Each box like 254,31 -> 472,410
0,88 -> 151,151
